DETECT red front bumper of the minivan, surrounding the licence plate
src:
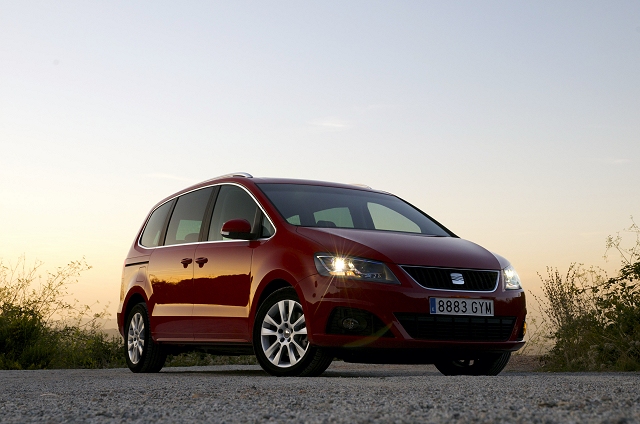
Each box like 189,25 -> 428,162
299,275 -> 526,362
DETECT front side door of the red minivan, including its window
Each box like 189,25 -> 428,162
193,184 -> 264,342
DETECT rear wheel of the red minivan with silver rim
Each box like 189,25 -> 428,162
124,303 -> 167,372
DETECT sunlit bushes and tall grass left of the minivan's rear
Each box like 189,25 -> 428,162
0,257 -> 124,369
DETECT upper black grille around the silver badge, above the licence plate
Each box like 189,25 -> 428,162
402,265 -> 500,291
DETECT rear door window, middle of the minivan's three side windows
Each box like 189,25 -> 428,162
164,187 -> 213,245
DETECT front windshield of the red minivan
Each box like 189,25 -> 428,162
258,184 -> 451,237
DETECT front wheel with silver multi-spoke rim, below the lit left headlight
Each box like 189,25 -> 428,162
253,287 -> 333,377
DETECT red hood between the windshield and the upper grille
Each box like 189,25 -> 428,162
297,227 -> 501,270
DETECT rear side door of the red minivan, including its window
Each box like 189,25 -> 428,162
149,187 -> 213,341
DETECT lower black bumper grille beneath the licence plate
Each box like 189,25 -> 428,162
395,313 -> 516,342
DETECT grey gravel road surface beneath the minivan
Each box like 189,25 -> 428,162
0,362 -> 640,423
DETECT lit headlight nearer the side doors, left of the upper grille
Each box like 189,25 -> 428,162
314,253 -> 400,284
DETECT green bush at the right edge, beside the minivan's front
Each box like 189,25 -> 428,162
538,219 -> 640,371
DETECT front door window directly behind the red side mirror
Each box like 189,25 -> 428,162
208,185 -> 259,241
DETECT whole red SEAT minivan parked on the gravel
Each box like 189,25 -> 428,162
118,174 -> 526,376
